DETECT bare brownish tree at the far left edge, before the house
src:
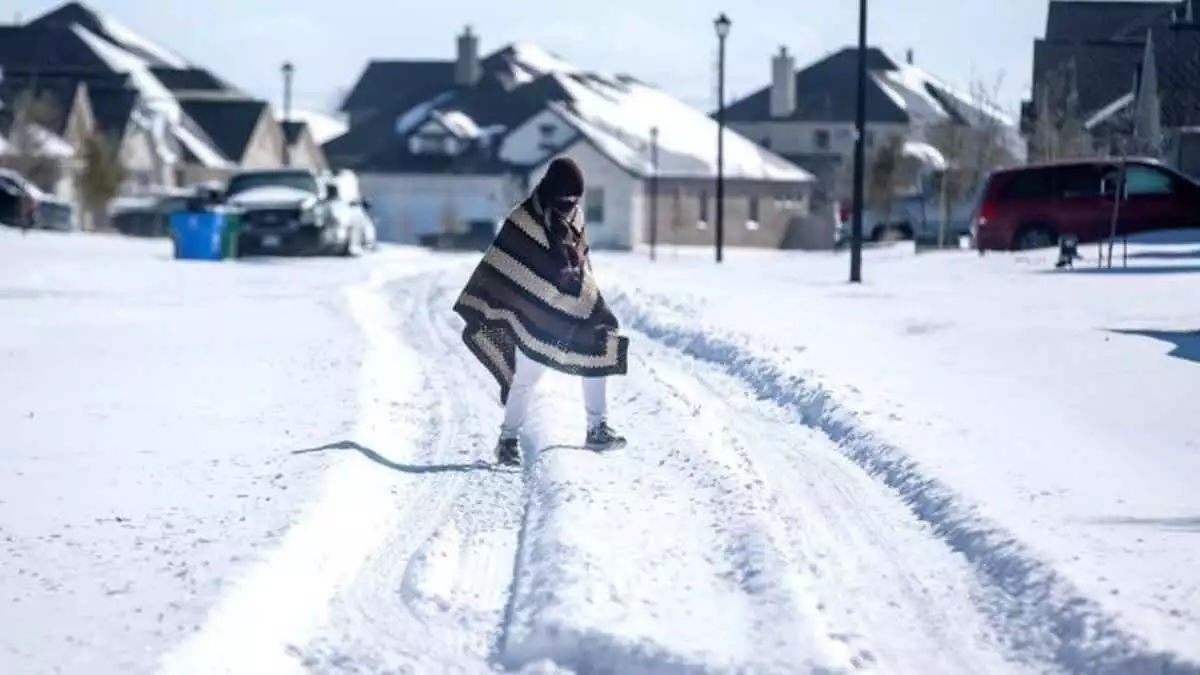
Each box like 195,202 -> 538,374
0,91 -> 62,192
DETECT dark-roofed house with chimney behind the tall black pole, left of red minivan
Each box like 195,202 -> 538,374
714,47 -> 1019,197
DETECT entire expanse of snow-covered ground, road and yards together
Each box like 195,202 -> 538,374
0,227 -> 1200,674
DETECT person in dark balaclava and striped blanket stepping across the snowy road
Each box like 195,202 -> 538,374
454,156 -> 629,465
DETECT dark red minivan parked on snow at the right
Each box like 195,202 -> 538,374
971,157 -> 1200,252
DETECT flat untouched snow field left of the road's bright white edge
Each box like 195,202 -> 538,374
0,228 -> 361,673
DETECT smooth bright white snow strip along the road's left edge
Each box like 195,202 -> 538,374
160,258 -> 456,675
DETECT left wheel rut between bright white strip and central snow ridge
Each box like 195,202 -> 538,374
297,265 -> 522,673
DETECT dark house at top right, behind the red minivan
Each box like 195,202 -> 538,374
1022,0 -> 1200,175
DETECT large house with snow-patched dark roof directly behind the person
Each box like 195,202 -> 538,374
325,28 -> 816,250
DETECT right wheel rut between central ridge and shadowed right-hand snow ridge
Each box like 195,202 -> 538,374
635,334 -> 1032,675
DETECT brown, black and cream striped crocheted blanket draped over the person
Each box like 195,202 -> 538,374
454,197 -> 629,404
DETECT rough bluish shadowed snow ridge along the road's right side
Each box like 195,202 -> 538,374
611,291 -> 1200,675
